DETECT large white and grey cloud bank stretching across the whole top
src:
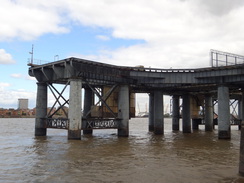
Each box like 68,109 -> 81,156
0,0 -> 244,68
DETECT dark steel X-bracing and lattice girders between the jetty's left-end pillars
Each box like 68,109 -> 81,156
46,80 -> 119,130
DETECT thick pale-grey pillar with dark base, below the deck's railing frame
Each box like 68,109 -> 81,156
218,86 -> 231,139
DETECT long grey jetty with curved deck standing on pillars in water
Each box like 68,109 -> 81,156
29,50 -> 244,175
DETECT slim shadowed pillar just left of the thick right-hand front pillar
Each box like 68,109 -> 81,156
204,94 -> 213,131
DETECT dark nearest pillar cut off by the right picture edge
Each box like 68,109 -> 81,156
239,91 -> 244,176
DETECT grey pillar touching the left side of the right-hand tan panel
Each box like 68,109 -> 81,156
182,94 -> 191,133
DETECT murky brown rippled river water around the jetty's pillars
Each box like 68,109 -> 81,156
0,118 -> 244,183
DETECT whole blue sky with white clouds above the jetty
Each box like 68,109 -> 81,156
0,0 -> 244,110
